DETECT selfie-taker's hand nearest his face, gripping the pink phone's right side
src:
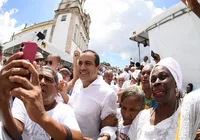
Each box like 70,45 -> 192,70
9,60 -> 46,123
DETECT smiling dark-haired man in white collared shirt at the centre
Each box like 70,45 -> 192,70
69,50 -> 117,140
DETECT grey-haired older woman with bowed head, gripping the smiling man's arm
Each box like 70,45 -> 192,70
102,85 -> 145,140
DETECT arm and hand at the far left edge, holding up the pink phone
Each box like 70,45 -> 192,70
0,52 -> 26,139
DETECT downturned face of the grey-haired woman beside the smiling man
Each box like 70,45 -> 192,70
121,96 -> 143,125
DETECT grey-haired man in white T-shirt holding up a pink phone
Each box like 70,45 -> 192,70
0,52 -> 83,140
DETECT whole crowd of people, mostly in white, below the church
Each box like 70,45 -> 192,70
0,0 -> 200,140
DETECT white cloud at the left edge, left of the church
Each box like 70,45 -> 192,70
0,0 -> 24,43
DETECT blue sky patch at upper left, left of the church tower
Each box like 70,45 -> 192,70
2,0 -> 60,26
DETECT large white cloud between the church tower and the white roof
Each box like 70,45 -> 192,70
85,0 -> 164,60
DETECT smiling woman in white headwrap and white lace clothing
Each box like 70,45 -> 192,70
128,58 -> 200,140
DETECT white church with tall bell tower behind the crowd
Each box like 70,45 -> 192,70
4,0 -> 91,63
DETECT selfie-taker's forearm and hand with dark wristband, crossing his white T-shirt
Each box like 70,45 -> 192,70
9,60 -> 82,140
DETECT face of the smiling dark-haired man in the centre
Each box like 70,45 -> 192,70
78,52 -> 99,86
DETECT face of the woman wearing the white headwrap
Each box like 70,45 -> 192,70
151,65 -> 176,103
